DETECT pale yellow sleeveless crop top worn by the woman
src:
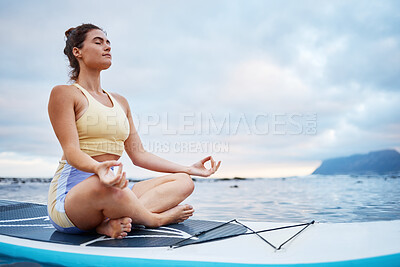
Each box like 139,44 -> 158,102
74,83 -> 129,156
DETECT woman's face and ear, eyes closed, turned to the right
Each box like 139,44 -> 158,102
74,30 -> 111,70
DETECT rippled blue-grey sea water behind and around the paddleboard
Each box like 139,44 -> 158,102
0,174 -> 400,266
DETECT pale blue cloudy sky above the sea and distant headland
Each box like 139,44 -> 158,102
0,0 -> 400,178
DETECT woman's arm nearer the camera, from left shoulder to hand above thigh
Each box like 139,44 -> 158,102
48,85 -> 125,186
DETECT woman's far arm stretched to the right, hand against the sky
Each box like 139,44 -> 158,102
114,94 -> 221,176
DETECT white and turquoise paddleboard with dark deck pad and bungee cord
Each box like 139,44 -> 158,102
0,200 -> 400,266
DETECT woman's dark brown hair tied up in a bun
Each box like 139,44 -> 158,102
64,23 -> 105,81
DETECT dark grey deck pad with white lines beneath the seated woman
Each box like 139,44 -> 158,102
0,200 -> 247,247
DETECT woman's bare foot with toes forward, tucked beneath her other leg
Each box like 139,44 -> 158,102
96,217 -> 132,239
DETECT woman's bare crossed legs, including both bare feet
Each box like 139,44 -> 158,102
65,173 -> 194,238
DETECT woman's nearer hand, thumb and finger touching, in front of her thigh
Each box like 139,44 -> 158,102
96,160 -> 128,189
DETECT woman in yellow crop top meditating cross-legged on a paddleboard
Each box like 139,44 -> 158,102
48,24 -> 221,238
